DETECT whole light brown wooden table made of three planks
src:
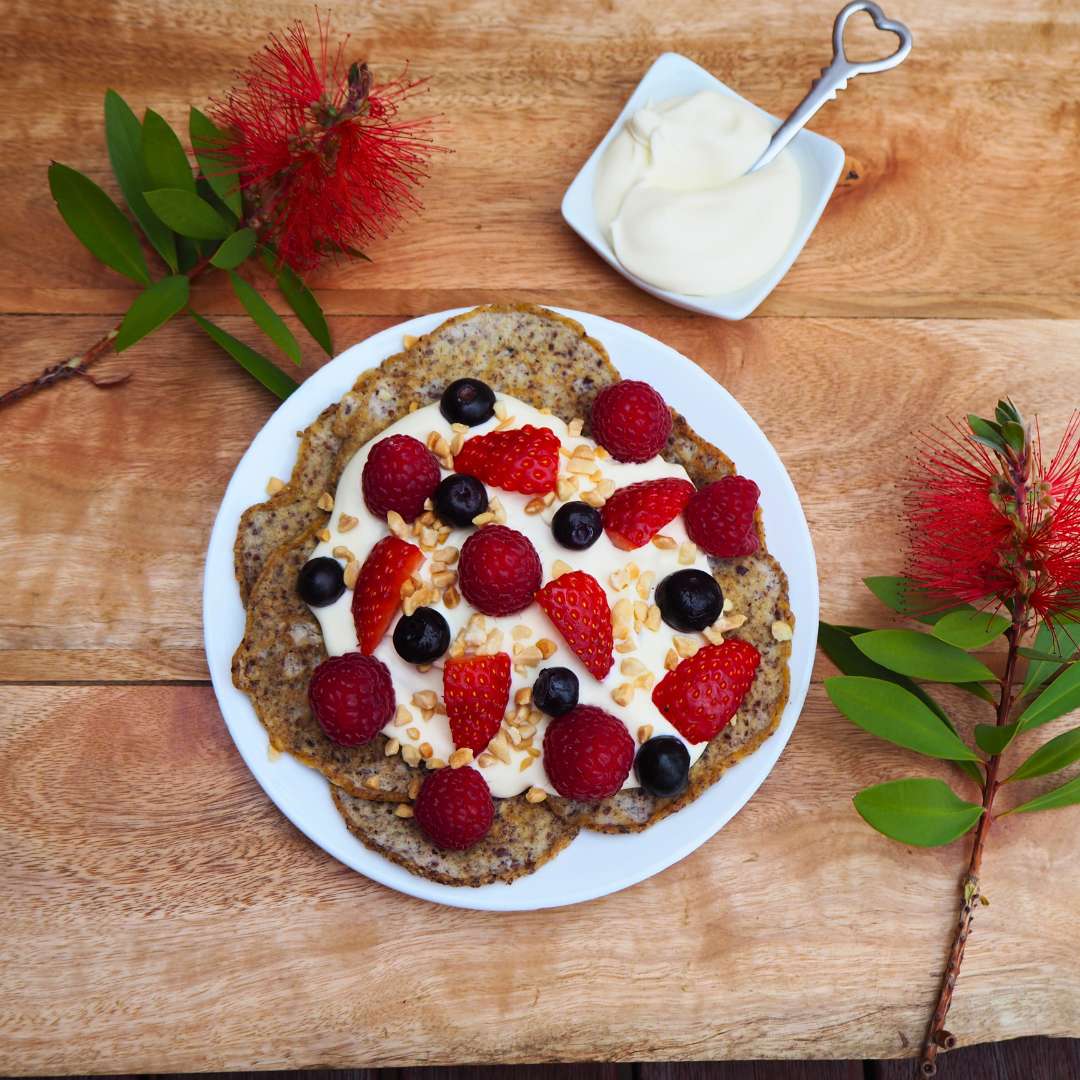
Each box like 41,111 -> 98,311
0,0 -> 1080,1072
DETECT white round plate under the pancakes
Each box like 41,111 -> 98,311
203,309 -> 818,912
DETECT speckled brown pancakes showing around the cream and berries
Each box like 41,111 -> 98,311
233,305 -> 793,886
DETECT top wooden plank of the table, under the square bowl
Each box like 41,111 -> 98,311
0,0 -> 1080,316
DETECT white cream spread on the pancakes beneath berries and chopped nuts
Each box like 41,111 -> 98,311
311,394 -> 721,798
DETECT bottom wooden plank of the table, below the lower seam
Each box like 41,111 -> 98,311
0,686 -> 1080,1074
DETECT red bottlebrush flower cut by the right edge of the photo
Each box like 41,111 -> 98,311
905,402 -> 1080,620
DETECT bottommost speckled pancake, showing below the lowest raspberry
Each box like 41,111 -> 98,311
333,787 -> 578,887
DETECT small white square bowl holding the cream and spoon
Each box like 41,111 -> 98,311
563,53 -> 843,319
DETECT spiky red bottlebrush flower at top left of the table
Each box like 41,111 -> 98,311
211,12 -> 443,270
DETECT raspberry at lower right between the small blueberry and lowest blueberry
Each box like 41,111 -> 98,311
543,705 -> 634,801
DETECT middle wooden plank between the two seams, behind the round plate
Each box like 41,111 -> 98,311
0,315 -> 1080,680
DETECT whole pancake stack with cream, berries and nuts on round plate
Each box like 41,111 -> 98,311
233,306 -> 794,886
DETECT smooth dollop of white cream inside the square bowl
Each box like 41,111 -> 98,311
593,91 -> 801,296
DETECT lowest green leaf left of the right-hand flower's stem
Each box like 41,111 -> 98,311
854,780 -> 983,848
